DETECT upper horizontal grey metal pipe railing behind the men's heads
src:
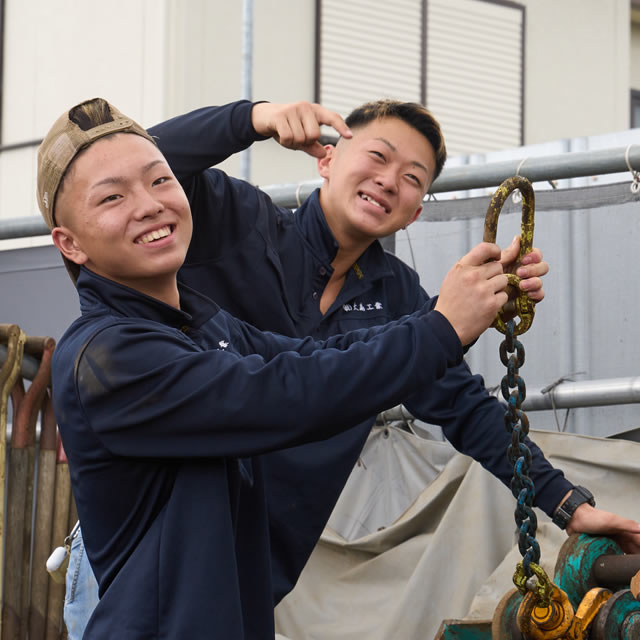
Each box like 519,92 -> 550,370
5,144 -> 640,240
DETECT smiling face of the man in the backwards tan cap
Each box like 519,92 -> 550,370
52,133 -> 192,297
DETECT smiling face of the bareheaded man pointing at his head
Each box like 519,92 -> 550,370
318,117 -> 436,245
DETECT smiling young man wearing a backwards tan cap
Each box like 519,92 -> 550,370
38,99 -> 507,640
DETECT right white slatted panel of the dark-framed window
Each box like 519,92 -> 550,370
426,0 -> 524,155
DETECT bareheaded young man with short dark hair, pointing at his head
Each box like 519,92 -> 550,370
58,97 -> 638,636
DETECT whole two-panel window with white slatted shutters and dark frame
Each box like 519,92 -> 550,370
316,0 -> 525,155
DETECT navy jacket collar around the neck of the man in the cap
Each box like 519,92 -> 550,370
76,267 -> 220,329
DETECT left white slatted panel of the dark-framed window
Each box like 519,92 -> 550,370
318,0 -> 423,115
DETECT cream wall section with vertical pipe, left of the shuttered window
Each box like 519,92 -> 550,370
161,0 -> 316,184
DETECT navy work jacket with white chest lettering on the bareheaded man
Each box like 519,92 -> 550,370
150,101 -> 573,592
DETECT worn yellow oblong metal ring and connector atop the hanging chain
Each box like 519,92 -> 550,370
483,176 -> 535,335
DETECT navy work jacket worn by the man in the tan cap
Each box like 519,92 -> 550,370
52,267 -> 462,640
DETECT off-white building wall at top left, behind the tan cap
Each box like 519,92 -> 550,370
0,0 -> 166,225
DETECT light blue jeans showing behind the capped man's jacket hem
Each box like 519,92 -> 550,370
64,530 -> 98,640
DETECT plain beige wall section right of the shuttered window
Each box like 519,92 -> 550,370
521,0 -> 631,144
